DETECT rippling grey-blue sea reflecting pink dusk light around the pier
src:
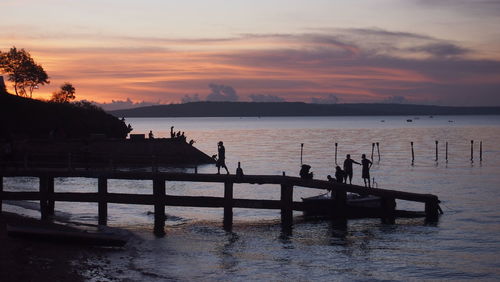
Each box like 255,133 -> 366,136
4,116 -> 500,281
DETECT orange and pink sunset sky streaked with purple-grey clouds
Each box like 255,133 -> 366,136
0,0 -> 500,107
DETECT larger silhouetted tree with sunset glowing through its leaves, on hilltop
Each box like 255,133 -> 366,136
0,47 -> 50,98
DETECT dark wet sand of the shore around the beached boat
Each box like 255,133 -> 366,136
0,212 -> 117,282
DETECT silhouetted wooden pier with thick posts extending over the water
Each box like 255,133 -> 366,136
0,169 -> 439,236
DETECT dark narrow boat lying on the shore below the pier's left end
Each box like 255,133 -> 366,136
7,225 -> 127,247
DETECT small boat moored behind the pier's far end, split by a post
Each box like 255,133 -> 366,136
302,193 -> 382,218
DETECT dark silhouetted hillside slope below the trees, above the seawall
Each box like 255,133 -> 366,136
0,93 -> 130,139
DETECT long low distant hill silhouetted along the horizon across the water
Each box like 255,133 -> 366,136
110,102 -> 500,117
